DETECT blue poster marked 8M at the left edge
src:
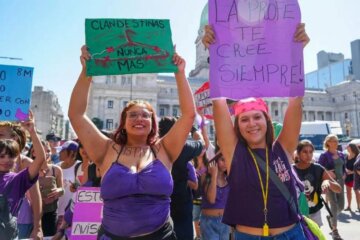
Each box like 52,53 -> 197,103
0,65 -> 34,121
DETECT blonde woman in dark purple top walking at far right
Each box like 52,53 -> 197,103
318,134 -> 345,240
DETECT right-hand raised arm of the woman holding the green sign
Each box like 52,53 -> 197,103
161,54 -> 196,162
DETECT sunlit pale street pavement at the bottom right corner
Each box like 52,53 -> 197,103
321,192 -> 360,240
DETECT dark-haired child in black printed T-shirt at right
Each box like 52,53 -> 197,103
294,140 -> 341,226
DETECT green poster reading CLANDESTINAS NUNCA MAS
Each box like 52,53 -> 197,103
85,19 -> 177,76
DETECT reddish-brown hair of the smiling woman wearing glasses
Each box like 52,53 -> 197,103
113,100 -> 158,146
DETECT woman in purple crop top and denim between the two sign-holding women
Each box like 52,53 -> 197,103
200,153 -> 230,240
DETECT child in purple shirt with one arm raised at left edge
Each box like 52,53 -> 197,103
0,112 -> 46,239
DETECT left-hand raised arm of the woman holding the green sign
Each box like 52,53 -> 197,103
68,46 -> 110,165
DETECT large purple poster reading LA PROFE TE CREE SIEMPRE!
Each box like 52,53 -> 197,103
209,0 -> 305,99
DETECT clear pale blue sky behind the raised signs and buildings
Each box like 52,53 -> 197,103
0,0 -> 360,116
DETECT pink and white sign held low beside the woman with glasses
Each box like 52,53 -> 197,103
71,187 -> 103,240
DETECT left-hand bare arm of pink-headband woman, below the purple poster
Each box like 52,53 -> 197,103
212,98 -> 237,173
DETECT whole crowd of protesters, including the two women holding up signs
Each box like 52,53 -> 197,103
0,18 -> 360,240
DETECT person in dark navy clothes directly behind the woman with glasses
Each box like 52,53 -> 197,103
159,117 -> 204,239
